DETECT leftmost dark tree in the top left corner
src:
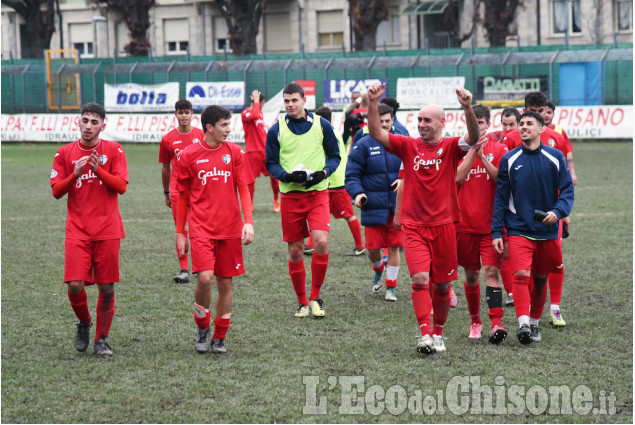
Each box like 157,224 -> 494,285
2,0 -> 55,59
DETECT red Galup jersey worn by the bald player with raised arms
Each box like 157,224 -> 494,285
388,133 -> 469,226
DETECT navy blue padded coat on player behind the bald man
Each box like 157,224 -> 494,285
346,134 -> 401,226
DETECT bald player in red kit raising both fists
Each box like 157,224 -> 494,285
368,82 -> 479,354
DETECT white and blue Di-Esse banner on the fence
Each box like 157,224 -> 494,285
185,81 -> 245,111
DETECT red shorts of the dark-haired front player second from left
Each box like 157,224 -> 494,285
190,236 -> 245,277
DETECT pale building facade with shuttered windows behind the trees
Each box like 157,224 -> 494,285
1,0 -> 633,59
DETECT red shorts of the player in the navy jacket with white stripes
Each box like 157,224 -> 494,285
509,236 -> 563,275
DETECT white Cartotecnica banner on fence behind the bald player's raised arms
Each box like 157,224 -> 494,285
397,77 -> 465,109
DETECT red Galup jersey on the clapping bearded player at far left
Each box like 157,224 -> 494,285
51,139 -> 128,241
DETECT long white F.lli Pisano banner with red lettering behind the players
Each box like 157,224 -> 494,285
0,103 -> 633,143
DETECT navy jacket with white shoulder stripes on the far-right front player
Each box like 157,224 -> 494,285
492,144 -> 574,239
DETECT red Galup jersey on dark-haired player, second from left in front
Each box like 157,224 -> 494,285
177,140 -> 254,239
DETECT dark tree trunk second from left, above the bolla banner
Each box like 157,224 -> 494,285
94,0 -> 156,56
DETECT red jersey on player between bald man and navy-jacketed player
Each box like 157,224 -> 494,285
454,141 -> 507,235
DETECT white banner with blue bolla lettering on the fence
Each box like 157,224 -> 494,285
104,83 -> 179,112
